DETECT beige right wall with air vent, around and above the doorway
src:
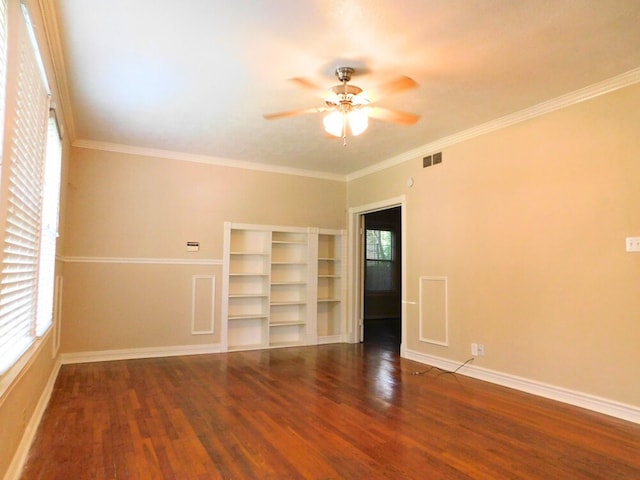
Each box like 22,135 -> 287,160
348,81 -> 640,406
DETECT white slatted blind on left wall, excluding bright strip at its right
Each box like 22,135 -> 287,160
0,3 -> 49,374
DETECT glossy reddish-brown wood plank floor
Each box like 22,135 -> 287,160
22,344 -> 640,480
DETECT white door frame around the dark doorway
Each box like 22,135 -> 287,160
346,195 -> 407,356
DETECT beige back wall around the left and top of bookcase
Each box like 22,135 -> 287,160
62,148 -> 346,353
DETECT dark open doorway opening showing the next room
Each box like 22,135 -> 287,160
362,206 -> 402,352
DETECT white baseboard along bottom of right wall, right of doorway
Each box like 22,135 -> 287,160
402,349 -> 640,424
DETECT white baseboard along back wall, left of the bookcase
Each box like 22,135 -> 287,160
60,343 -> 221,365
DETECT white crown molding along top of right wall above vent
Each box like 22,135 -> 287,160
346,68 -> 640,182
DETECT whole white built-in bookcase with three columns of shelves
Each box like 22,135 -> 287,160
221,223 -> 346,351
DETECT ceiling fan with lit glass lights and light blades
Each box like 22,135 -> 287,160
264,67 -> 420,145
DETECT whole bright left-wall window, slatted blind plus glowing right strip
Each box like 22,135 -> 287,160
0,0 -> 60,374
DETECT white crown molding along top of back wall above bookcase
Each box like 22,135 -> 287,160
72,139 -> 346,182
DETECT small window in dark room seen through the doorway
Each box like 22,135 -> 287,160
365,229 -> 396,292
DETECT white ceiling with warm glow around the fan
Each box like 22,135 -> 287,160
48,0 -> 640,175
